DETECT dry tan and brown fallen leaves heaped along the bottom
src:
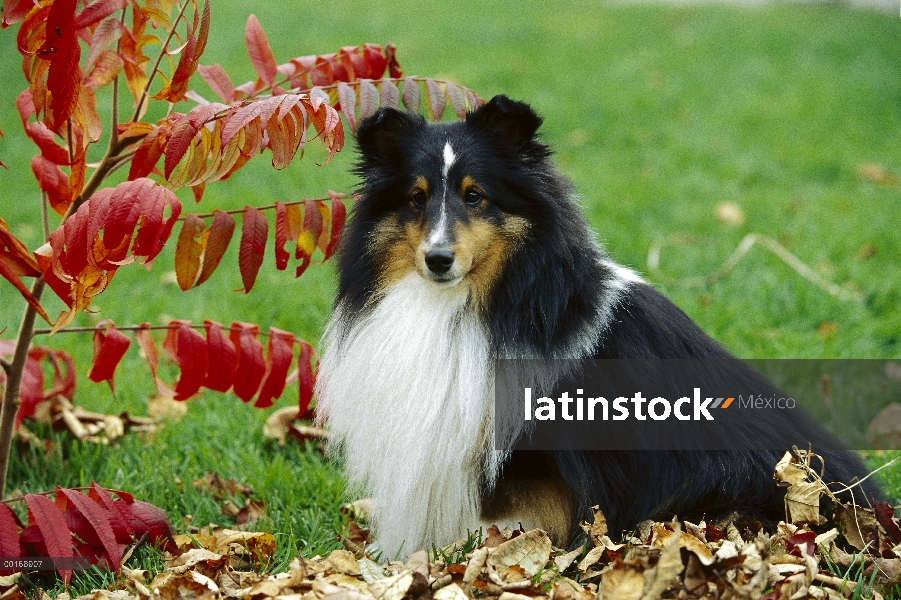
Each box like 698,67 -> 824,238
0,449 -> 901,600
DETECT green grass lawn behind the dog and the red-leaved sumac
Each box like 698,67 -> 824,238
0,0 -> 901,592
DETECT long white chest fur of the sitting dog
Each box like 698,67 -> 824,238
316,274 -> 499,558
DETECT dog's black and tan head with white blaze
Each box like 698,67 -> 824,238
342,96 -> 549,308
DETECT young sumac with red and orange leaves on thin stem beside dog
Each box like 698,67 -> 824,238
0,0 -> 482,500
